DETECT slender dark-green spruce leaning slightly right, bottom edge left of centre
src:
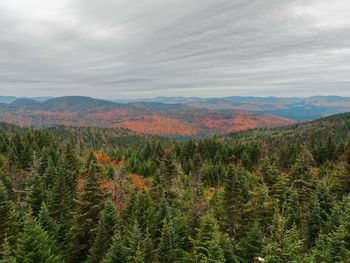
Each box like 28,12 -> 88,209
86,200 -> 117,263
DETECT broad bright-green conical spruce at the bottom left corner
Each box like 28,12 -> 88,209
15,214 -> 62,263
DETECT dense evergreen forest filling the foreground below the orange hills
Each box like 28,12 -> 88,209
0,114 -> 350,263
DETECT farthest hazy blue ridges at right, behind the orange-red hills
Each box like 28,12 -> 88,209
116,96 -> 350,122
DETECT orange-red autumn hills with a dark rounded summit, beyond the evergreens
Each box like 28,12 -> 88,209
0,96 -> 295,138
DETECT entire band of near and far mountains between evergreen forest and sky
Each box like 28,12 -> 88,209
0,96 -> 350,138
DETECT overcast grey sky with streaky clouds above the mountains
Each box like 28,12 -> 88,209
0,0 -> 350,99
